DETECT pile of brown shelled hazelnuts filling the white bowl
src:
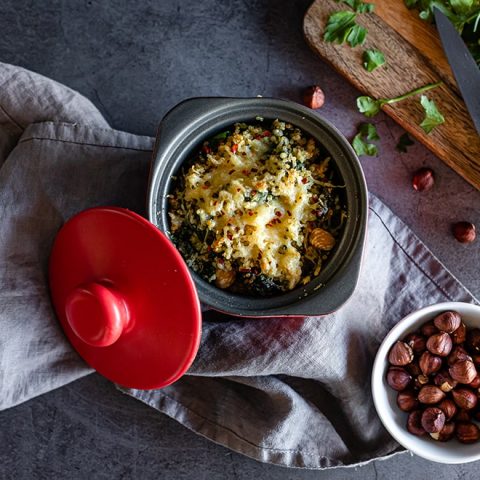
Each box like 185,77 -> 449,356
387,311 -> 480,443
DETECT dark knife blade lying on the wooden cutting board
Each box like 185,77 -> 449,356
434,8 -> 480,134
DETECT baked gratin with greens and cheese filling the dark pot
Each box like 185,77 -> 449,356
169,118 -> 346,296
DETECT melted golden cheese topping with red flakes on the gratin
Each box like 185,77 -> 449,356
170,120 -> 326,289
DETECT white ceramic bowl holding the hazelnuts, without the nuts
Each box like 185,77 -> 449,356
372,302 -> 480,463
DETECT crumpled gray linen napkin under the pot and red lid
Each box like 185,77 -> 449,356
0,64 -> 475,468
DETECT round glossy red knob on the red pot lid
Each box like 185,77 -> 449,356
65,283 -> 129,347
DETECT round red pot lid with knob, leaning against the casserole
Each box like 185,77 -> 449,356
50,208 -> 202,389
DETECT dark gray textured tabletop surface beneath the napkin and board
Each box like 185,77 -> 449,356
0,0 -> 480,480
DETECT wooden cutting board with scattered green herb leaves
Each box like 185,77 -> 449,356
303,0 -> 480,190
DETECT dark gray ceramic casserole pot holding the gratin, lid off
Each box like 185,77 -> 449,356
148,97 -> 368,317
